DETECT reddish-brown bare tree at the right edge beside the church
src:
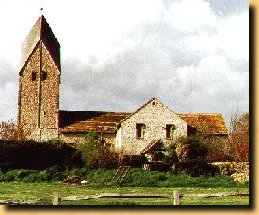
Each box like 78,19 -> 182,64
228,113 -> 249,162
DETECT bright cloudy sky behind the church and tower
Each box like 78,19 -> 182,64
0,0 -> 249,126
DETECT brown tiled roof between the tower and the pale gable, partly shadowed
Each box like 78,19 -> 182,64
59,111 -> 130,133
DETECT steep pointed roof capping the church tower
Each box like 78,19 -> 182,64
21,15 -> 61,70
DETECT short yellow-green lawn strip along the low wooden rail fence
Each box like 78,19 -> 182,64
0,182 -> 249,206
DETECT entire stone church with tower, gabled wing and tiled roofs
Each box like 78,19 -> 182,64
18,15 -> 228,154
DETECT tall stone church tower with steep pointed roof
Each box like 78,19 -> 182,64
18,15 -> 61,141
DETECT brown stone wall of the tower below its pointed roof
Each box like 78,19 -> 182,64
18,43 -> 60,141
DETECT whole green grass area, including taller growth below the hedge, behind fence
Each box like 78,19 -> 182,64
0,168 -> 249,206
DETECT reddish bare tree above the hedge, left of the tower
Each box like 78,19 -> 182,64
0,121 -> 25,140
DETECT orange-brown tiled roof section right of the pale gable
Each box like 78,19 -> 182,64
177,113 -> 228,134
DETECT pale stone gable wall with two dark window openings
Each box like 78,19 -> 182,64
116,99 -> 187,154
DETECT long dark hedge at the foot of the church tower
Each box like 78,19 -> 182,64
0,140 -> 83,171
